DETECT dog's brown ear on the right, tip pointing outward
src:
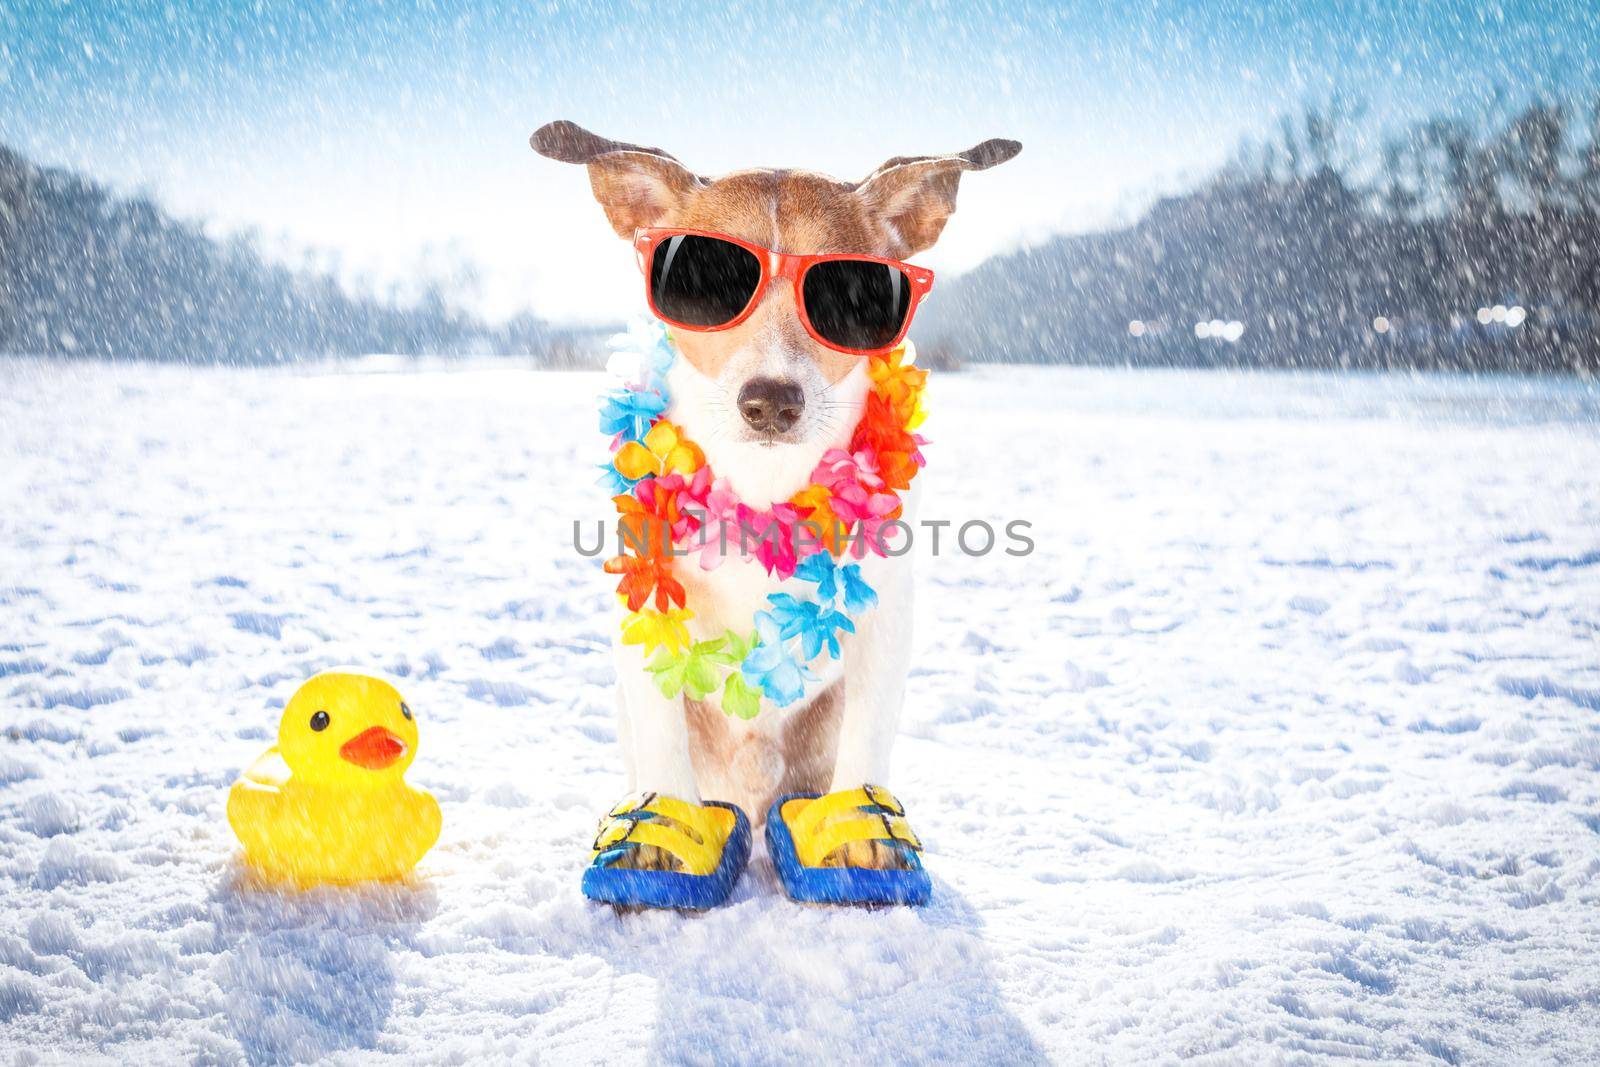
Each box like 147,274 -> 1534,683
856,138 -> 1022,259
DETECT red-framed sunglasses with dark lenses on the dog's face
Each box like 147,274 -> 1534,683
634,229 -> 933,355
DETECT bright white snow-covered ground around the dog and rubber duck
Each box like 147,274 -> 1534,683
0,362 -> 1600,1064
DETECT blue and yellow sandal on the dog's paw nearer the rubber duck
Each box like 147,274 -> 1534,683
584,793 -> 750,910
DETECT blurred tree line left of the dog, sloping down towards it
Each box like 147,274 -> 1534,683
0,146 -> 571,363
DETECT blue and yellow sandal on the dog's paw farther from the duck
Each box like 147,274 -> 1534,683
766,785 -> 933,905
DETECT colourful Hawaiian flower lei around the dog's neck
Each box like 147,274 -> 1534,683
600,323 -> 928,718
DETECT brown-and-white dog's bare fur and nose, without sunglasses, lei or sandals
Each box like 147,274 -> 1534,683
531,122 -> 1021,865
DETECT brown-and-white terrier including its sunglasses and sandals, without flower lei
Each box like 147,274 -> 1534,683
531,122 -> 1021,907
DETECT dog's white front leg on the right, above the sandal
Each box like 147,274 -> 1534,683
832,558 -> 912,792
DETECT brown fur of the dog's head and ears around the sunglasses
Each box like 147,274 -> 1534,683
531,122 -> 1022,382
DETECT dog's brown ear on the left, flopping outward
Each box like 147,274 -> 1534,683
528,118 -> 706,240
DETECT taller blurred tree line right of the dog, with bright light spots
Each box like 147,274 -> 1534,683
918,102 -> 1600,373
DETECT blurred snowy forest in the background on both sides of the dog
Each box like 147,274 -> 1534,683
9,102 -> 1600,373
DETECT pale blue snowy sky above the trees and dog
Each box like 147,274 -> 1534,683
0,0 -> 1600,318
